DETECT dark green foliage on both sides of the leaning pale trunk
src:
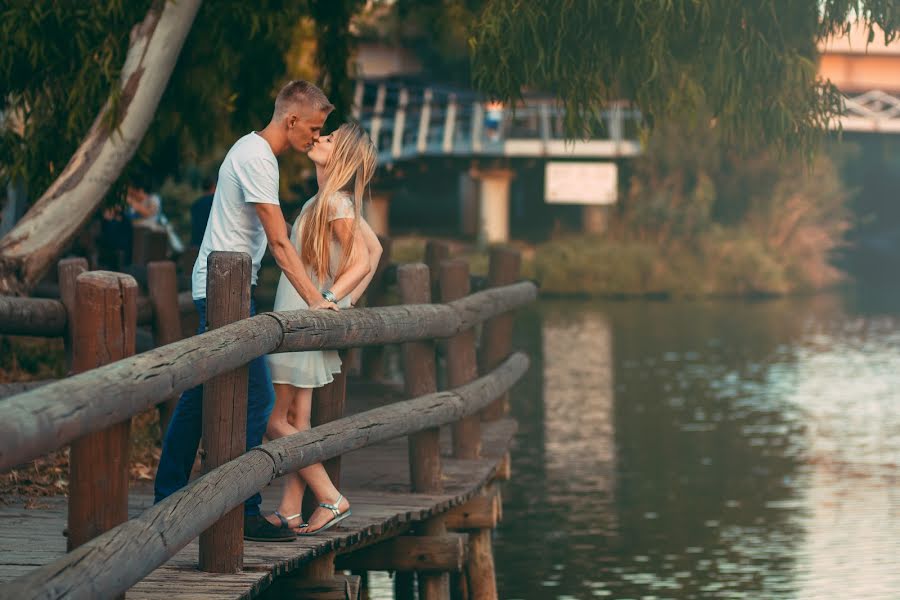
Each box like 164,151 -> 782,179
0,0 -> 361,203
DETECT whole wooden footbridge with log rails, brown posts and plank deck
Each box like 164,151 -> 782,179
0,243 -> 536,600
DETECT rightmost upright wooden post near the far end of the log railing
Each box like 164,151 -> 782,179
478,247 -> 522,420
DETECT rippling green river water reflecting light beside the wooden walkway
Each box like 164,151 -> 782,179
372,290 -> 900,600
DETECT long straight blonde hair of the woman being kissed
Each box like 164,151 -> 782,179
299,123 -> 376,281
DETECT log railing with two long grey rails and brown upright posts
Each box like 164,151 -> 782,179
0,241 -> 537,600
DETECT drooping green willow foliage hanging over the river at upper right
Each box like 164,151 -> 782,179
470,0 -> 900,155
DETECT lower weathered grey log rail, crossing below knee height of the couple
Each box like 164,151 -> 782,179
0,354 -> 528,600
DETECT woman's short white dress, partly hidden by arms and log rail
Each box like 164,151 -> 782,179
266,191 -> 354,388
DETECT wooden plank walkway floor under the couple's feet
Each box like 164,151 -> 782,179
0,383 -> 516,600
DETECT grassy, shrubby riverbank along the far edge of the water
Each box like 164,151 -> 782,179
391,228 -> 846,299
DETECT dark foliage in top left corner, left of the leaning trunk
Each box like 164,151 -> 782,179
0,0 -> 150,190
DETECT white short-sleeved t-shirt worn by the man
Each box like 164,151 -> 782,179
191,133 -> 278,300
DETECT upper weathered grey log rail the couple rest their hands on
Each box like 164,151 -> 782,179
0,282 -> 537,470
